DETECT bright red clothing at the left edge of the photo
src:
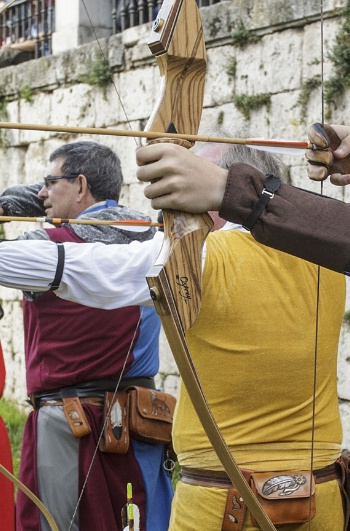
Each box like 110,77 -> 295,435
0,343 -> 15,531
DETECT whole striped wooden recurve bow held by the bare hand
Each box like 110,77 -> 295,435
147,0 -> 275,531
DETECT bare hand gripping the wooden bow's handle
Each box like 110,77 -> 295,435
136,143 -> 228,213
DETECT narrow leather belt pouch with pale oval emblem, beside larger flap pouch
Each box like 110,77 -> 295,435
99,392 -> 130,454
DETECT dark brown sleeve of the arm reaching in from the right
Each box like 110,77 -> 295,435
220,164 -> 350,273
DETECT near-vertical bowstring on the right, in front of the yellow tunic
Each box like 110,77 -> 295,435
308,0 -> 325,531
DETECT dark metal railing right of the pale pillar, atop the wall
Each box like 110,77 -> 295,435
112,0 -> 221,34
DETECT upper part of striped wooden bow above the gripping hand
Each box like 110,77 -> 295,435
145,0 -> 207,139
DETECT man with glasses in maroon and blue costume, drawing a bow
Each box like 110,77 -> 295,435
0,142 -> 172,531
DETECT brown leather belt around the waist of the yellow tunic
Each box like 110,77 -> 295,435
180,463 -> 340,489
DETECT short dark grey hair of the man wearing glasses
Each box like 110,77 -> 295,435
49,141 -> 123,201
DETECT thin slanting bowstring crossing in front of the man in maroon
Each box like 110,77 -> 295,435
68,0 -> 144,531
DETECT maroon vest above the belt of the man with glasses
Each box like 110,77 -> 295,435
23,228 -> 140,394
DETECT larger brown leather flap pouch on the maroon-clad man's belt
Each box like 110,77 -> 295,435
125,386 -> 176,444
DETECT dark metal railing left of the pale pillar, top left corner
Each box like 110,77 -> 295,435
0,0 -> 55,58
